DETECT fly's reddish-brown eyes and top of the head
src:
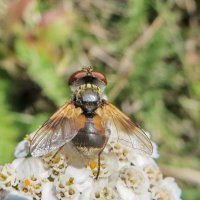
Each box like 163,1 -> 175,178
68,67 -> 107,85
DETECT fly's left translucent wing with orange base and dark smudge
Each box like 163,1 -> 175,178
30,102 -> 82,157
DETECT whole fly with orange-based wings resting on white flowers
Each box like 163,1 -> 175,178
30,67 -> 152,178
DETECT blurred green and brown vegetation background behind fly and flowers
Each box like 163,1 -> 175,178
0,0 -> 200,200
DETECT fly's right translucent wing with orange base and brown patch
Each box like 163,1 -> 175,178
96,101 -> 153,155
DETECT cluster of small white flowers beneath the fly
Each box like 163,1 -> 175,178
0,132 -> 181,200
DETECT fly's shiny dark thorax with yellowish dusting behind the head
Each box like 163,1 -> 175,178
74,83 -> 102,113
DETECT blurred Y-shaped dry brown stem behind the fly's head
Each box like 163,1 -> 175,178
85,15 -> 164,100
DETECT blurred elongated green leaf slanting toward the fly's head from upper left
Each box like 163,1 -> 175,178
16,40 -> 69,106
